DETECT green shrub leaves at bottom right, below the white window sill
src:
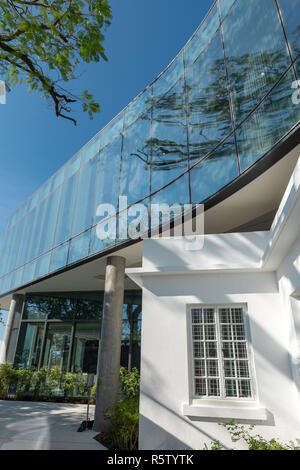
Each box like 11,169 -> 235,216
204,420 -> 300,451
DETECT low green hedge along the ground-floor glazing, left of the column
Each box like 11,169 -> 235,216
0,363 -> 96,402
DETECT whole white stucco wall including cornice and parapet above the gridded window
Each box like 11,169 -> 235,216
127,157 -> 300,450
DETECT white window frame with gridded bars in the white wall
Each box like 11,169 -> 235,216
187,303 -> 258,404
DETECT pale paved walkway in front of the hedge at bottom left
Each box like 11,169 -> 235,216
0,400 -> 105,450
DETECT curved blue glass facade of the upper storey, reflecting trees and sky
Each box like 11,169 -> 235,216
0,0 -> 300,295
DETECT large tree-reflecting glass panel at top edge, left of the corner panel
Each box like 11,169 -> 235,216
223,0 -> 290,123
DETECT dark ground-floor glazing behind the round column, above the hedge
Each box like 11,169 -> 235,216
14,291 -> 142,373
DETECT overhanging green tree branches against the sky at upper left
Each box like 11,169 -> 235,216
0,0 -> 112,125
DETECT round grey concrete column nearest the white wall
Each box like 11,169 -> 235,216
94,256 -> 126,432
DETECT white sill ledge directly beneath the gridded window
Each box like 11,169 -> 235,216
183,403 -> 268,421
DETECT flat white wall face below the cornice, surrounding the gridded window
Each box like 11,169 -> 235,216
136,258 -> 300,449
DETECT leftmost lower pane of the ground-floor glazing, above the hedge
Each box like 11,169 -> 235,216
14,323 -> 44,369
